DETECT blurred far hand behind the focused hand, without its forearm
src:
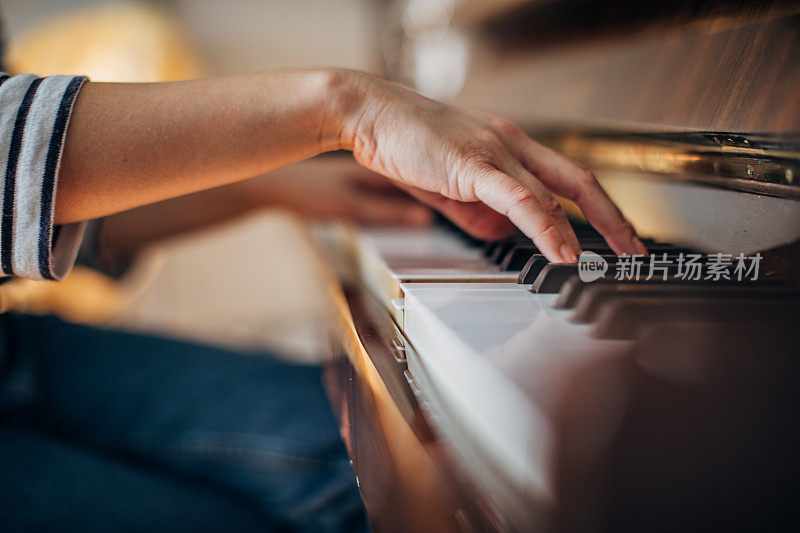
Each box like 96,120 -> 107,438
250,156 -> 433,227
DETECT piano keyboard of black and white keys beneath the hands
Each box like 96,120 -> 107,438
357,220 -> 800,529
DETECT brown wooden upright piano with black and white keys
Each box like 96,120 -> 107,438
318,0 -> 800,531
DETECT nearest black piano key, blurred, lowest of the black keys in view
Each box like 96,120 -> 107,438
592,297 -> 800,340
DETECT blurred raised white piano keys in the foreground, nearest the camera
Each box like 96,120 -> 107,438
401,283 -> 627,503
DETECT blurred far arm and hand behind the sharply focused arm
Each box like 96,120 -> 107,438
100,154 -> 434,263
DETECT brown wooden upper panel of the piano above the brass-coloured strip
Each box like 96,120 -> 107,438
457,2 -> 800,132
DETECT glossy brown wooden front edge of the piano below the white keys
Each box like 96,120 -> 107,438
326,287 -> 494,533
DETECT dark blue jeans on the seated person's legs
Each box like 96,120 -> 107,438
0,315 -> 368,532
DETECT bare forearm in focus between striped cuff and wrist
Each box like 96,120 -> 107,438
55,71 -> 352,223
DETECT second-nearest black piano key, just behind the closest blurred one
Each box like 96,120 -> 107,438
570,281 -> 800,324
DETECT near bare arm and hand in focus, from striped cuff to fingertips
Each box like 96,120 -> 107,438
55,70 -> 644,262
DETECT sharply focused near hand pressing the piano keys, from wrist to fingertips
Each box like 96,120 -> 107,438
340,72 -> 646,262
